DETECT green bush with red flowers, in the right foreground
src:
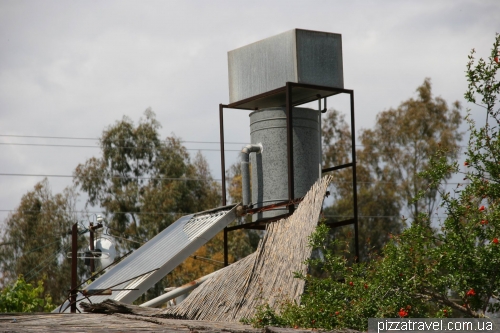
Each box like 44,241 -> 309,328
247,34 -> 500,330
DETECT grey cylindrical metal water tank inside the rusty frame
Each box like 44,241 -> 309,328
250,108 -> 321,221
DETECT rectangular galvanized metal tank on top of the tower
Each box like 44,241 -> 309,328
228,29 -> 344,103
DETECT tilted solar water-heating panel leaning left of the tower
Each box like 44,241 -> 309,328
54,205 -> 236,312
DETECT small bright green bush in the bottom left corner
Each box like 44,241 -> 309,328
0,275 -> 55,312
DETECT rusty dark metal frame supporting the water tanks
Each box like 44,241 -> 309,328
219,82 -> 359,266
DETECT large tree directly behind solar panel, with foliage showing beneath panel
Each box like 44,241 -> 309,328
74,108 -> 258,302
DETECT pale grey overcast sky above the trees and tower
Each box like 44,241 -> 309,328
0,0 -> 500,223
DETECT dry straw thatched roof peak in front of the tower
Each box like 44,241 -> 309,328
157,176 -> 331,322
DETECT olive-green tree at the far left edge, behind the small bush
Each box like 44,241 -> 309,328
0,179 -> 85,302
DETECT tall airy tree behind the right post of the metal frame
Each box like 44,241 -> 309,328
323,79 -> 462,258
